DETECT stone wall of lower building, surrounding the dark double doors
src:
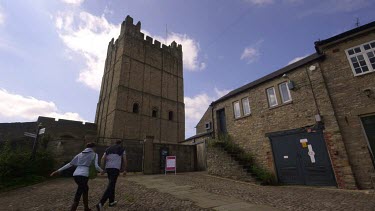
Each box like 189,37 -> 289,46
213,61 -> 355,188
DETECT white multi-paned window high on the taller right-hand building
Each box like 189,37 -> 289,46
345,40 -> 375,76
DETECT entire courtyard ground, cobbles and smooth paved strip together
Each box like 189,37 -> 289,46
0,173 -> 375,211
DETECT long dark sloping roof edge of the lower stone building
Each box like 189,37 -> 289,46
211,53 -> 324,106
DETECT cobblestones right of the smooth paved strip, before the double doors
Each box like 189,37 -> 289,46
168,173 -> 375,211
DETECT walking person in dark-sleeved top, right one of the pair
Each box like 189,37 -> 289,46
96,140 -> 126,210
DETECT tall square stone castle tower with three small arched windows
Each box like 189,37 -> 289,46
95,16 -> 185,144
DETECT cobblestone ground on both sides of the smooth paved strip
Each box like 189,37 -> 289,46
0,173 -> 375,211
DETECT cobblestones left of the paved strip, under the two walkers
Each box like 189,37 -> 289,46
0,177 -> 212,211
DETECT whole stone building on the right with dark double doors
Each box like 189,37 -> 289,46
193,22 -> 375,189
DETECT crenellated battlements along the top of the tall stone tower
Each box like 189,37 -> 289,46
107,15 -> 182,57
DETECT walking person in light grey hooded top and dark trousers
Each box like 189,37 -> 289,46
51,143 -> 103,211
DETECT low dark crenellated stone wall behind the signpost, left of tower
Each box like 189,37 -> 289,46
0,116 -> 96,166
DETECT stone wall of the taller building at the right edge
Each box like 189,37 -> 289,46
320,29 -> 375,188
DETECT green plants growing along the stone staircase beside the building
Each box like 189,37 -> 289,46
209,134 -> 277,185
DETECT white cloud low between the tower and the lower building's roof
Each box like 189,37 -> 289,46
184,87 -> 229,136
